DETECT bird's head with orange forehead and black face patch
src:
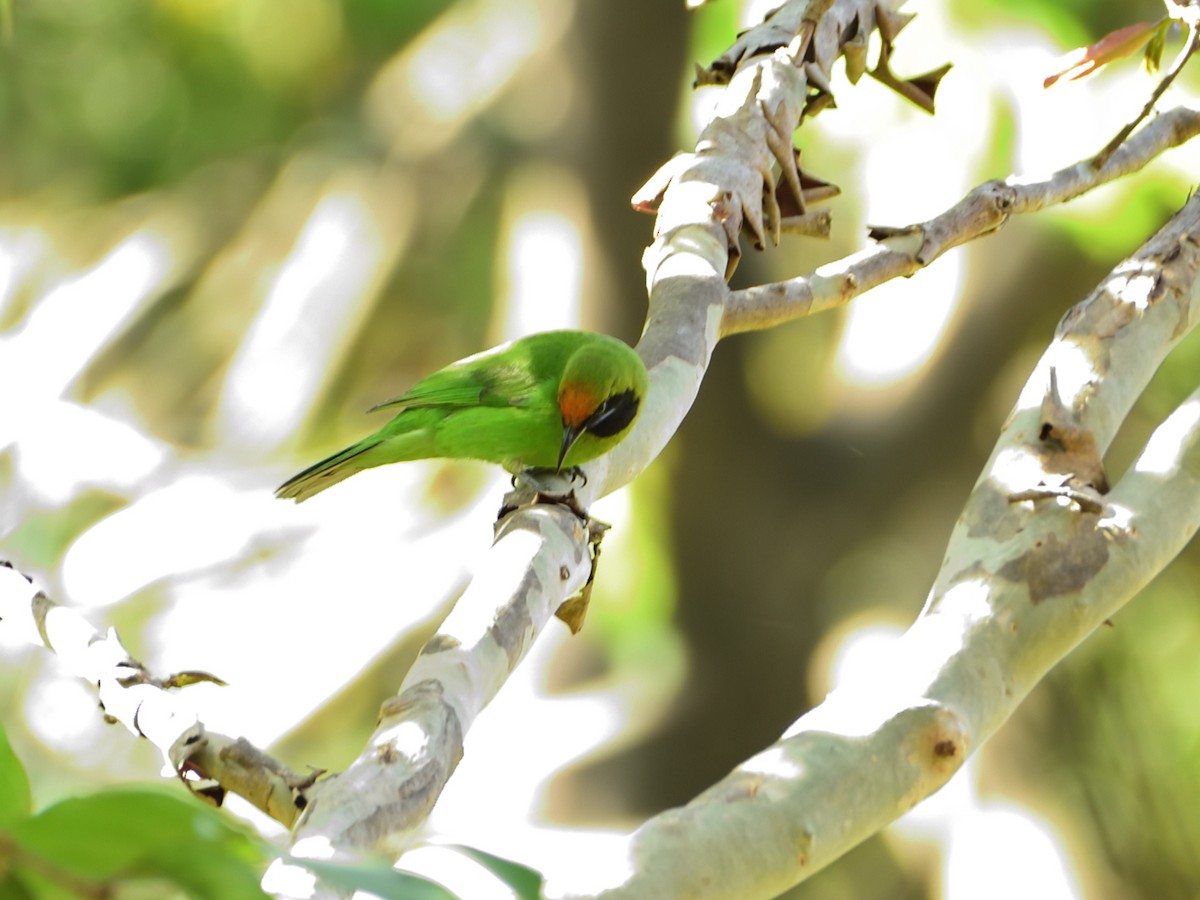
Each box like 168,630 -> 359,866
558,338 -> 648,469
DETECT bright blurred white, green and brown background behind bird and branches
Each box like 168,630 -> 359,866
0,0 -> 1200,900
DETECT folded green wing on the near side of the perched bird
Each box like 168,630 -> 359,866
371,356 -> 538,412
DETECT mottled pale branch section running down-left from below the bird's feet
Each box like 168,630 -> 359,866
280,501 -> 590,866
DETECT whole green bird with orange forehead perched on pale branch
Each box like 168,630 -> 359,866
275,331 -> 648,503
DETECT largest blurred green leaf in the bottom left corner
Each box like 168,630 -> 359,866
11,788 -> 266,900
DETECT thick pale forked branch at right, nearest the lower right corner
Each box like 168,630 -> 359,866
552,177 -> 1200,900
